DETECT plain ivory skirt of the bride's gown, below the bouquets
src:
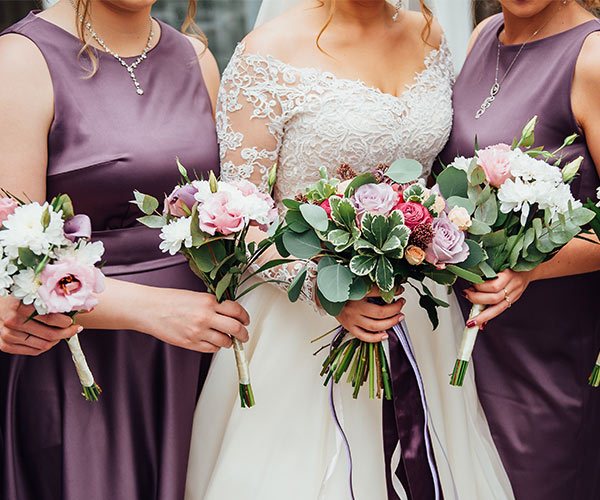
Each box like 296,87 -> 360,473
185,284 -> 514,500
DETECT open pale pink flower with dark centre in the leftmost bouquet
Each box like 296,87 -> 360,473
38,258 -> 104,313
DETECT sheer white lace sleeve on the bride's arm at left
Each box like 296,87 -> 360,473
216,44 -> 316,307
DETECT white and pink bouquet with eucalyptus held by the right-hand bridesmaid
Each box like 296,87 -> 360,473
437,117 -> 596,386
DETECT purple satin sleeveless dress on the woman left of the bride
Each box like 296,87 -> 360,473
0,13 -> 219,500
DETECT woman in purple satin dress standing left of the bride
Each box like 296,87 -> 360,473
0,0 -> 248,500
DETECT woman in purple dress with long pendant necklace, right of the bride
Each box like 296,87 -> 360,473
442,0 -> 600,500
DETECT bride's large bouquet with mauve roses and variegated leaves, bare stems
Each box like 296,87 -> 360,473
282,159 -> 484,399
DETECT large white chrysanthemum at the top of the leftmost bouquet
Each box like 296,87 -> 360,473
0,202 -> 67,259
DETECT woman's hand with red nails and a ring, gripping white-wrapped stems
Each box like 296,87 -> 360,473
463,269 -> 533,328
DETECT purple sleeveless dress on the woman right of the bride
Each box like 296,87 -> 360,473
442,15 -> 600,500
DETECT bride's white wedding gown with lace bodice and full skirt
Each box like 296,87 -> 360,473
186,39 -> 512,500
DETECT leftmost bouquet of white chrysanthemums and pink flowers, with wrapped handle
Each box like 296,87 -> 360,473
0,191 -> 104,401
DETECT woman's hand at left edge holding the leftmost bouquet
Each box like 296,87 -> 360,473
0,298 -> 83,356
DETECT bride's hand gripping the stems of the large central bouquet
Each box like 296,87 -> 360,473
337,287 -> 406,343
